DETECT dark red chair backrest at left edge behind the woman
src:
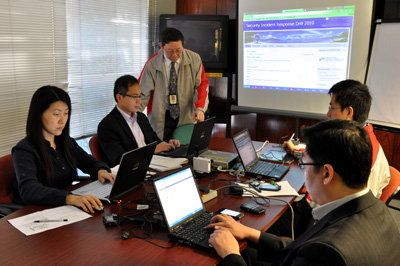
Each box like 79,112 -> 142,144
0,154 -> 16,203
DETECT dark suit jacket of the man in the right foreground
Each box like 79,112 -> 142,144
221,192 -> 400,265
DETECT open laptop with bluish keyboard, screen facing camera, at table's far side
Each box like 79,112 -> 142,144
233,129 -> 289,180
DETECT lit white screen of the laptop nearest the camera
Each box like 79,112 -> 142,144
154,168 -> 204,228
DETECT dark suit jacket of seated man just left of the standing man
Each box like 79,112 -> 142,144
97,107 -> 161,167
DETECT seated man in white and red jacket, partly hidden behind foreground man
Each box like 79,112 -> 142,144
276,79 -> 390,236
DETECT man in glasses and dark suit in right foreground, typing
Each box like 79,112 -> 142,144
209,120 -> 400,265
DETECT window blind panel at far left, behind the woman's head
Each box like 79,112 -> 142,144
0,0 -> 67,155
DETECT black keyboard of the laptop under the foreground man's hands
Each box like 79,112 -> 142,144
174,212 -> 213,243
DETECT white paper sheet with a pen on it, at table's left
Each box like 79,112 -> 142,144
8,206 -> 92,236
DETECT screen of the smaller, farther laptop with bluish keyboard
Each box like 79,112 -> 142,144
233,129 -> 258,168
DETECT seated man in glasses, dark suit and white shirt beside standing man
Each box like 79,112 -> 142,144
97,75 -> 180,167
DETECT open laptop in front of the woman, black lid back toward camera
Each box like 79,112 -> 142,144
71,142 -> 157,202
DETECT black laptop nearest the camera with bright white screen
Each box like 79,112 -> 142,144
154,167 -> 213,249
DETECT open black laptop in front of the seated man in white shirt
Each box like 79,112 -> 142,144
160,117 -> 215,158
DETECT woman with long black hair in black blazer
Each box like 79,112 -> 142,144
12,86 -> 114,213
